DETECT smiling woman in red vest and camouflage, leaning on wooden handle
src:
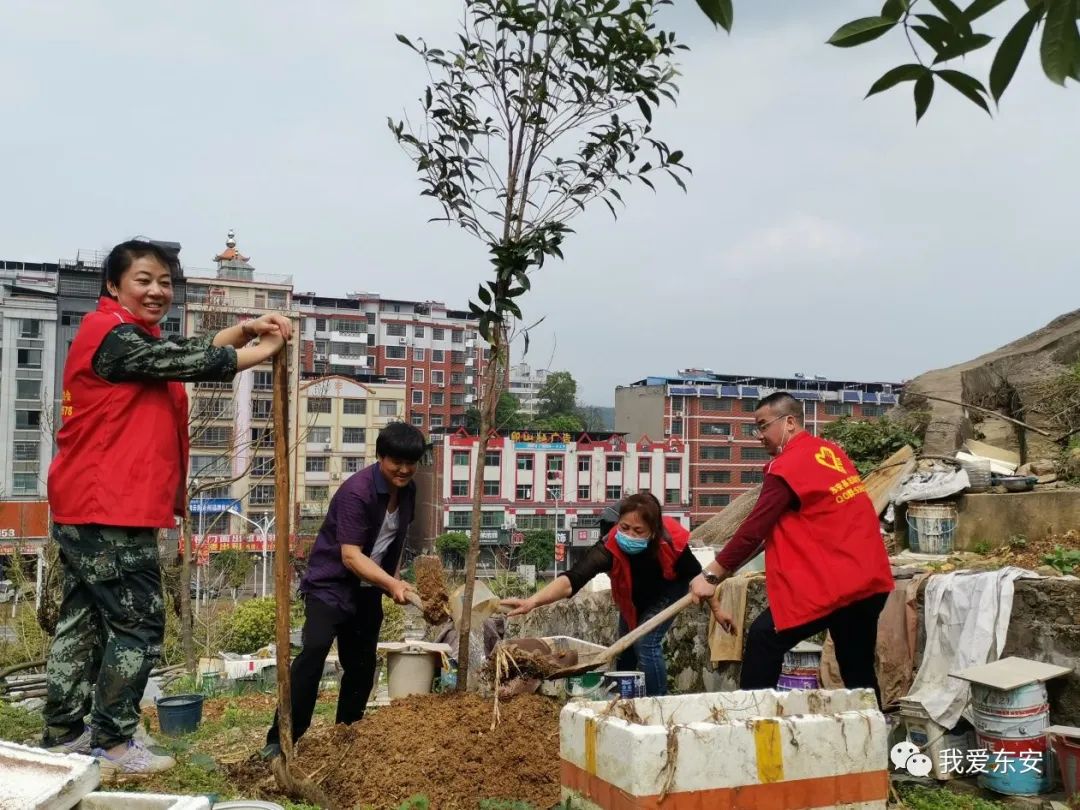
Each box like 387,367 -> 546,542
43,241 -> 291,773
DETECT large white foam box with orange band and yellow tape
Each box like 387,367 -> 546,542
559,689 -> 889,810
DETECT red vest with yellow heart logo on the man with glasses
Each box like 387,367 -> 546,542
765,433 -> 893,630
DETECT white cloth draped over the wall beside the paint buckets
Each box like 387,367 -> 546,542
906,566 -> 1039,729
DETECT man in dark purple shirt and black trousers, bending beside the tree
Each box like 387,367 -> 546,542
262,422 -> 424,758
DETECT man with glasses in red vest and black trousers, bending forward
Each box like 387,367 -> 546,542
690,392 -> 893,697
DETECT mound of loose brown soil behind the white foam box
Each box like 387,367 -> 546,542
230,692 -> 559,810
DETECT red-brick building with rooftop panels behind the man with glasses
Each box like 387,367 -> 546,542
615,369 -> 901,527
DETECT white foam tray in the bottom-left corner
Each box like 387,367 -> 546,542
0,741 -> 100,810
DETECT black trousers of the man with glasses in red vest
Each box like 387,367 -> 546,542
739,593 -> 889,705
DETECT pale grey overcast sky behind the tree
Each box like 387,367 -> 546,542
0,0 -> 1080,404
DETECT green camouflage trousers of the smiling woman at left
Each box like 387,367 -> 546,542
44,524 -> 165,747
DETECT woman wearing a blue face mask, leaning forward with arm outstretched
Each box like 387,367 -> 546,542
502,492 -> 701,697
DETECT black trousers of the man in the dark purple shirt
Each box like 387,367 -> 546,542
267,588 -> 382,743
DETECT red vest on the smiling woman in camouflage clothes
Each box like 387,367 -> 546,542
49,297 -> 188,528
